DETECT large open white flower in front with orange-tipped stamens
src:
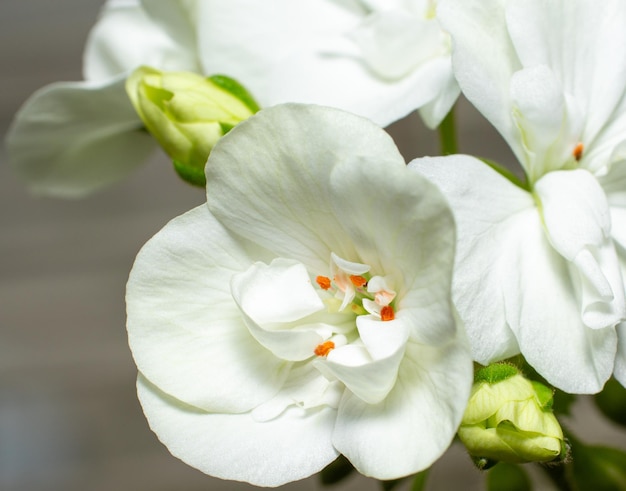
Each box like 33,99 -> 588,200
126,105 -> 472,486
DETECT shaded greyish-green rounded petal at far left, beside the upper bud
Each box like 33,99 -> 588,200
7,77 -> 155,197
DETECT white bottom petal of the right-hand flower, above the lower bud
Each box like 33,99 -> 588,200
502,211 -> 617,394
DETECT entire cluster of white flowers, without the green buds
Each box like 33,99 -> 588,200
8,0 -> 626,486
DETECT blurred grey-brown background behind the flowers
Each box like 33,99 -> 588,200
0,0 -> 626,491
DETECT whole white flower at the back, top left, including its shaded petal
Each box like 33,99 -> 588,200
7,0 -> 459,197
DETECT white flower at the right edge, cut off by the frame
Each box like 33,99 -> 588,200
415,0 -> 626,393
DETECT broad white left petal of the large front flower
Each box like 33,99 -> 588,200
126,206 -> 289,412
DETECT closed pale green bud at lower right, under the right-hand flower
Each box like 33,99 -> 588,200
459,364 -> 565,463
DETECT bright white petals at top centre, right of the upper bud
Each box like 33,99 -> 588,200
198,0 -> 459,127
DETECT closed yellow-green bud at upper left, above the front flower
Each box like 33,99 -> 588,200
126,67 -> 259,186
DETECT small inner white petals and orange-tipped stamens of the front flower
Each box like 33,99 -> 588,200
231,254 -> 409,404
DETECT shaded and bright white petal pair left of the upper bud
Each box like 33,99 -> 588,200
6,0 -> 199,197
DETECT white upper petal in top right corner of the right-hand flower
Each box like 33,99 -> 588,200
506,0 -> 626,150
